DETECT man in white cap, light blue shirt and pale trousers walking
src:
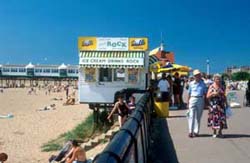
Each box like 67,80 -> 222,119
187,69 -> 207,138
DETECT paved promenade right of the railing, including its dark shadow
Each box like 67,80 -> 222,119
152,91 -> 250,163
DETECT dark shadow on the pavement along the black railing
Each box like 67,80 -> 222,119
149,118 -> 178,163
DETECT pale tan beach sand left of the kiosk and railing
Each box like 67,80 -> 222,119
0,88 -> 105,163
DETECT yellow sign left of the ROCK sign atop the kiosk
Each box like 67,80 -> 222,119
78,37 -> 97,51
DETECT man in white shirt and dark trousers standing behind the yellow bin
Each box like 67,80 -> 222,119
158,73 -> 170,101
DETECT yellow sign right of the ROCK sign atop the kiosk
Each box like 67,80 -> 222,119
129,38 -> 148,51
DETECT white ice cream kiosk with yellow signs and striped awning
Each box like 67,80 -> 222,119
78,37 -> 148,109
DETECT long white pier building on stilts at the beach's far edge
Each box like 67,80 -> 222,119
0,63 -> 79,87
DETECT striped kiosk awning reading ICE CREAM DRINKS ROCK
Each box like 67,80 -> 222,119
79,51 -> 145,68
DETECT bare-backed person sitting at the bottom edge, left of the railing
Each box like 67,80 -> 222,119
66,140 -> 87,163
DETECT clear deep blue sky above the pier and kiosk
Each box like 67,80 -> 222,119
0,0 -> 250,72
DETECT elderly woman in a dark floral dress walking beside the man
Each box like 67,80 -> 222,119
207,75 -> 227,137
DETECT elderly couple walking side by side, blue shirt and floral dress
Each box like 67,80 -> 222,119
187,70 -> 229,138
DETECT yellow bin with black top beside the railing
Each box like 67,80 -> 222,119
154,92 -> 169,118
